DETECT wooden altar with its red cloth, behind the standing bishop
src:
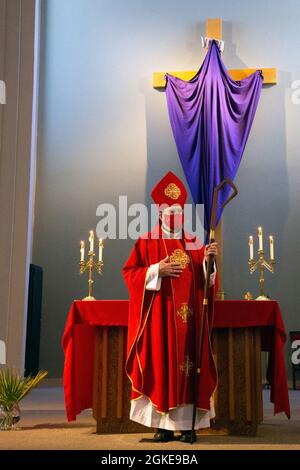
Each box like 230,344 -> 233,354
63,300 -> 290,435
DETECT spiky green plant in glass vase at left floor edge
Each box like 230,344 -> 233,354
0,369 -> 48,431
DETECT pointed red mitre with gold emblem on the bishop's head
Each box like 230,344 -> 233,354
151,171 -> 187,208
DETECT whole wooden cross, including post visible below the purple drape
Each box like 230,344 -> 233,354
153,18 -> 277,299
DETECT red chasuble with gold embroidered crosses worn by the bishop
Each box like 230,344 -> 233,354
123,228 -> 217,413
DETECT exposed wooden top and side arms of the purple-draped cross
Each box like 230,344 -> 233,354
153,18 -> 277,88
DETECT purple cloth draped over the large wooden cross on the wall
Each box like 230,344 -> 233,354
166,41 -> 263,235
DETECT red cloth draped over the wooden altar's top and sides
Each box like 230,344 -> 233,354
62,300 -> 290,421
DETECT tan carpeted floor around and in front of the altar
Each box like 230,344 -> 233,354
0,387 -> 300,450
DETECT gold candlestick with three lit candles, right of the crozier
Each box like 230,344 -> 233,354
249,227 -> 275,300
